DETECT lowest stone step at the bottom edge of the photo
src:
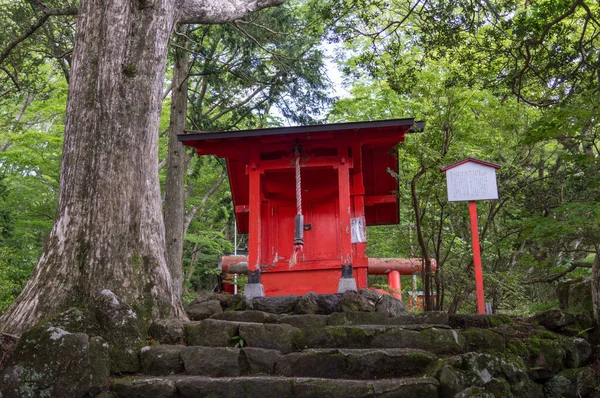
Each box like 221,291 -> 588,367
111,376 -> 439,398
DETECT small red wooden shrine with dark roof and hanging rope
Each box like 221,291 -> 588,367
178,119 -> 432,296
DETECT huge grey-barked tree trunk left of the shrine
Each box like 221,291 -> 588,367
0,0 -> 283,333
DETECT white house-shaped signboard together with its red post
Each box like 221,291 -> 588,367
442,158 -> 500,314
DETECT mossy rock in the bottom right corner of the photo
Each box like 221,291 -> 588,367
544,368 -> 598,398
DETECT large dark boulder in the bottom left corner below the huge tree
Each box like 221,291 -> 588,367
0,324 -> 94,398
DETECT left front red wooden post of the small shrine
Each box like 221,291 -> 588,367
248,156 -> 262,271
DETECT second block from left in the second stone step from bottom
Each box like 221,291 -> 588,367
181,347 -> 241,377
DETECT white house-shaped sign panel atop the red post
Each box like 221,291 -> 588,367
446,162 -> 498,202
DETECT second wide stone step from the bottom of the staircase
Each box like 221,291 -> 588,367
140,345 -> 437,379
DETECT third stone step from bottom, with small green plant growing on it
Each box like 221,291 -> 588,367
185,319 -> 466,355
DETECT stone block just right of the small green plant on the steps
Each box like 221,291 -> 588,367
239,323 -> 299,353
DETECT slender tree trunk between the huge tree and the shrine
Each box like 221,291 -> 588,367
164,25 -> 189,300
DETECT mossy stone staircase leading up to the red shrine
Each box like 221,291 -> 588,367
110,292 -> 454,398
